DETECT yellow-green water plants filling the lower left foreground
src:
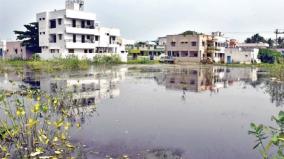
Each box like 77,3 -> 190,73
0,90 -> 85,158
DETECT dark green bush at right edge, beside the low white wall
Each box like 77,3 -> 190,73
258,49 -> 283,64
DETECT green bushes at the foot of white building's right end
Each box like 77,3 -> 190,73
93,55 -> 122,65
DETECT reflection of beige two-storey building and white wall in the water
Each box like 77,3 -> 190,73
155,67 -> 257,92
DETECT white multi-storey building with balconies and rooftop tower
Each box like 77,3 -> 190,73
37,0 -> 127,61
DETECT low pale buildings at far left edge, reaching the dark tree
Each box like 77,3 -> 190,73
0,41 -> 32,60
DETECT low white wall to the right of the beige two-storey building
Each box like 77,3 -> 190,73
225,48 -> 259,64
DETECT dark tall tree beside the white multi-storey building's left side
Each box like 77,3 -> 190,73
14,22 -> 41,53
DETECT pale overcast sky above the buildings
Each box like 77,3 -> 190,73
0,0 -> 284,40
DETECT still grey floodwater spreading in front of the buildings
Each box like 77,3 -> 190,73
0,65 -> 284,159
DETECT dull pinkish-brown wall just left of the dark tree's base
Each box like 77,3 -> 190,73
4,41 -> 32,60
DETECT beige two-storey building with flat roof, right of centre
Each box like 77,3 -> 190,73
166,32 -> 226,63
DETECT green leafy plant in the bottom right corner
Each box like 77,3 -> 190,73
249,111 -> 284,159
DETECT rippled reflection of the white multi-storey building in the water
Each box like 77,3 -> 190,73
40,69 -> 126,106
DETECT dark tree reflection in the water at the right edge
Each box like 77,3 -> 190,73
265,81 -> 284,106
